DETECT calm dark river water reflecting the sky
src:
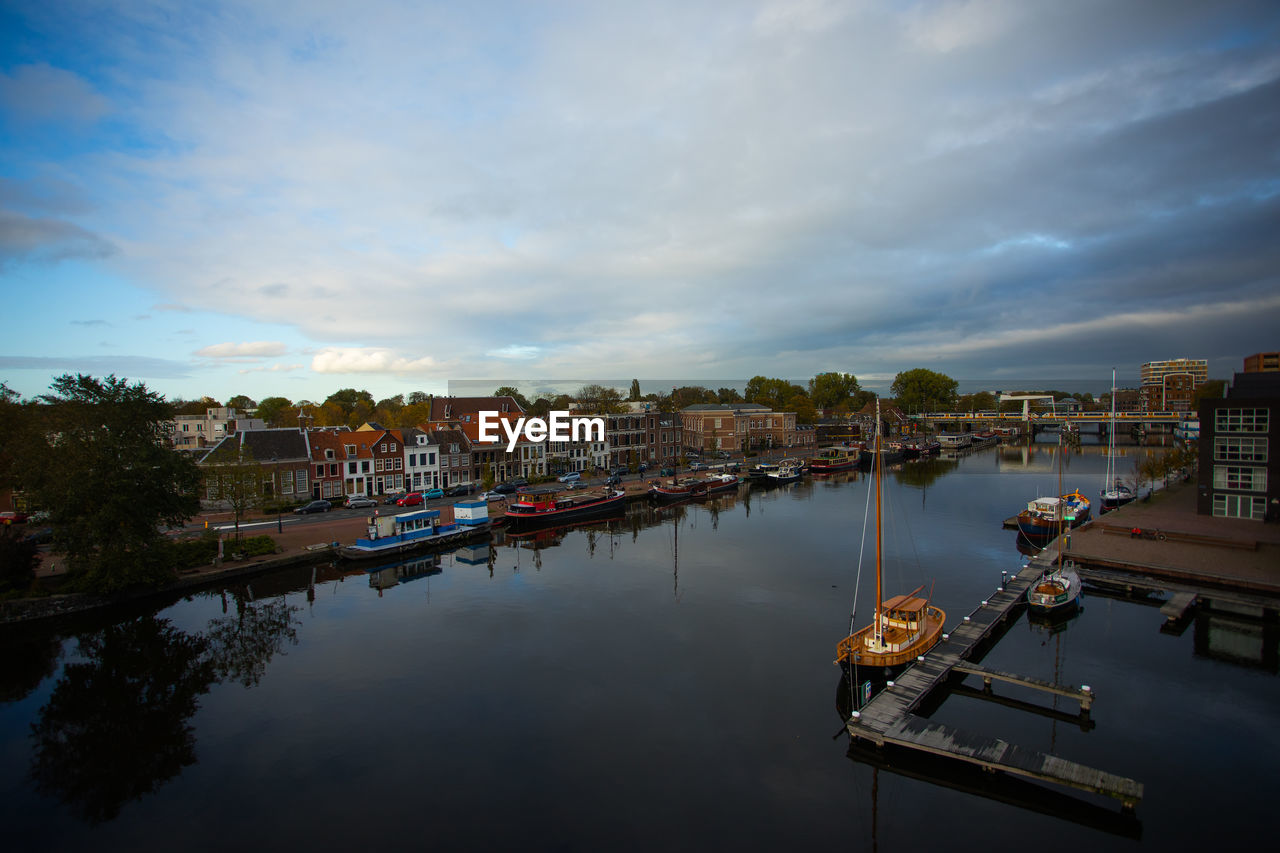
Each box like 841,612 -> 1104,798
0,446 -> 1280,850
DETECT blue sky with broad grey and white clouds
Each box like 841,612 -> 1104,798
0,0 -> 1280,401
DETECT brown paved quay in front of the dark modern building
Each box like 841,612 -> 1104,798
1065,480 -> 1280,596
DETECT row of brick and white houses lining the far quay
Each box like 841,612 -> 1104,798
192,397 -> 814,500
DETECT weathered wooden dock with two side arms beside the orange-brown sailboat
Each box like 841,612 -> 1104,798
845,540 -> 1143,809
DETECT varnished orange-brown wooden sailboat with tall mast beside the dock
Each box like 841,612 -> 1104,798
836,401 -> 947,669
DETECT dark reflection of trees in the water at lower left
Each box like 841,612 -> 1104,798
31,599 -> 298,822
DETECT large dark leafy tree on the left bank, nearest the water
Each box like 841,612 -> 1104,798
19,374 -> 200,592
